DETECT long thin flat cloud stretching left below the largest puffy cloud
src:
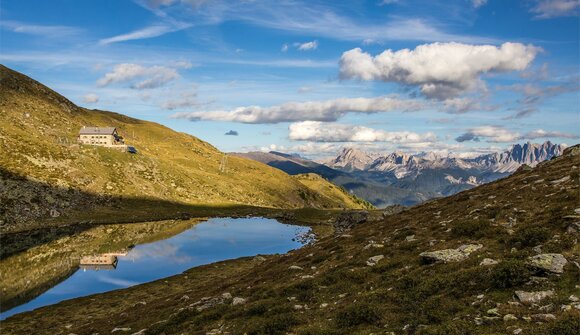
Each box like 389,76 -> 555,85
172,96 -> 424,123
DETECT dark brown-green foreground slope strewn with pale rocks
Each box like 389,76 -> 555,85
3,146 -> 580,335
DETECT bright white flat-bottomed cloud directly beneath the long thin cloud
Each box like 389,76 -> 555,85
288,121 -> 437,143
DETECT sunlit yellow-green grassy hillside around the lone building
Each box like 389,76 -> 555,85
0,65 -> 368,232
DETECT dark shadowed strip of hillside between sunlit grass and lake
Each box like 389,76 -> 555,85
0,167 -> 276,259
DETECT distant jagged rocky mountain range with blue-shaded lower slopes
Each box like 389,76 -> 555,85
237,141 -> 566,207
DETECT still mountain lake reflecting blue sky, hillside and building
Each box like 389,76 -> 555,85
0,218 -> 309,319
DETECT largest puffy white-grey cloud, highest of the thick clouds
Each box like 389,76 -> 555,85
340,42 -> 541,100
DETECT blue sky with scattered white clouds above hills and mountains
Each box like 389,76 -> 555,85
0,0 -> 580,158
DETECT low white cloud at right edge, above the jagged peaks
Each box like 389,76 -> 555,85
455,126 -> 578,143
